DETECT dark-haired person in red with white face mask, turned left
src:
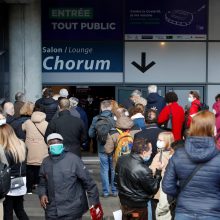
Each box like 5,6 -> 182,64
187,91 -> 201,128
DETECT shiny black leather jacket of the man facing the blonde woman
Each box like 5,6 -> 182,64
115,153 -> 161,208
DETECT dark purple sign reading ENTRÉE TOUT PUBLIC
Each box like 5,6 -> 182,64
42,0 -> 123,41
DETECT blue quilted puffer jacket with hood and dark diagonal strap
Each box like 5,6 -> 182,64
162,137 -> 220,219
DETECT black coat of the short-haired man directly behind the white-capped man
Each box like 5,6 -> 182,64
45,110 -> 87,157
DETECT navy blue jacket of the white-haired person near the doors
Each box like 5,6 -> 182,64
147,92 -> 166,114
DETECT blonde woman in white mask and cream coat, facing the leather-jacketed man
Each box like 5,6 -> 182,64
150,131 -> 174,220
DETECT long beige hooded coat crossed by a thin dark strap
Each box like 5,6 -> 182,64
22,111 -> 48,166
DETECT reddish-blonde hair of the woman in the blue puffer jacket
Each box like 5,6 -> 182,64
188,111 -> 215,137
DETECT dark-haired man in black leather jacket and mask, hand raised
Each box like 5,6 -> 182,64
115,138 -> 163,220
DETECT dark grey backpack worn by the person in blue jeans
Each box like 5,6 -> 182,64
95,116 -> 115,145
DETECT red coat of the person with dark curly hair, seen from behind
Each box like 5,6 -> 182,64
158,102 -> 185,141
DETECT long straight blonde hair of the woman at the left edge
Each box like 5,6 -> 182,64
0,124 -> 26,163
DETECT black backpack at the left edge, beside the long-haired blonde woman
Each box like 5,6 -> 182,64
0,162 -> 11,199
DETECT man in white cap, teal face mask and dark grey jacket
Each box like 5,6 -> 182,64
38,133 -> 101,220
